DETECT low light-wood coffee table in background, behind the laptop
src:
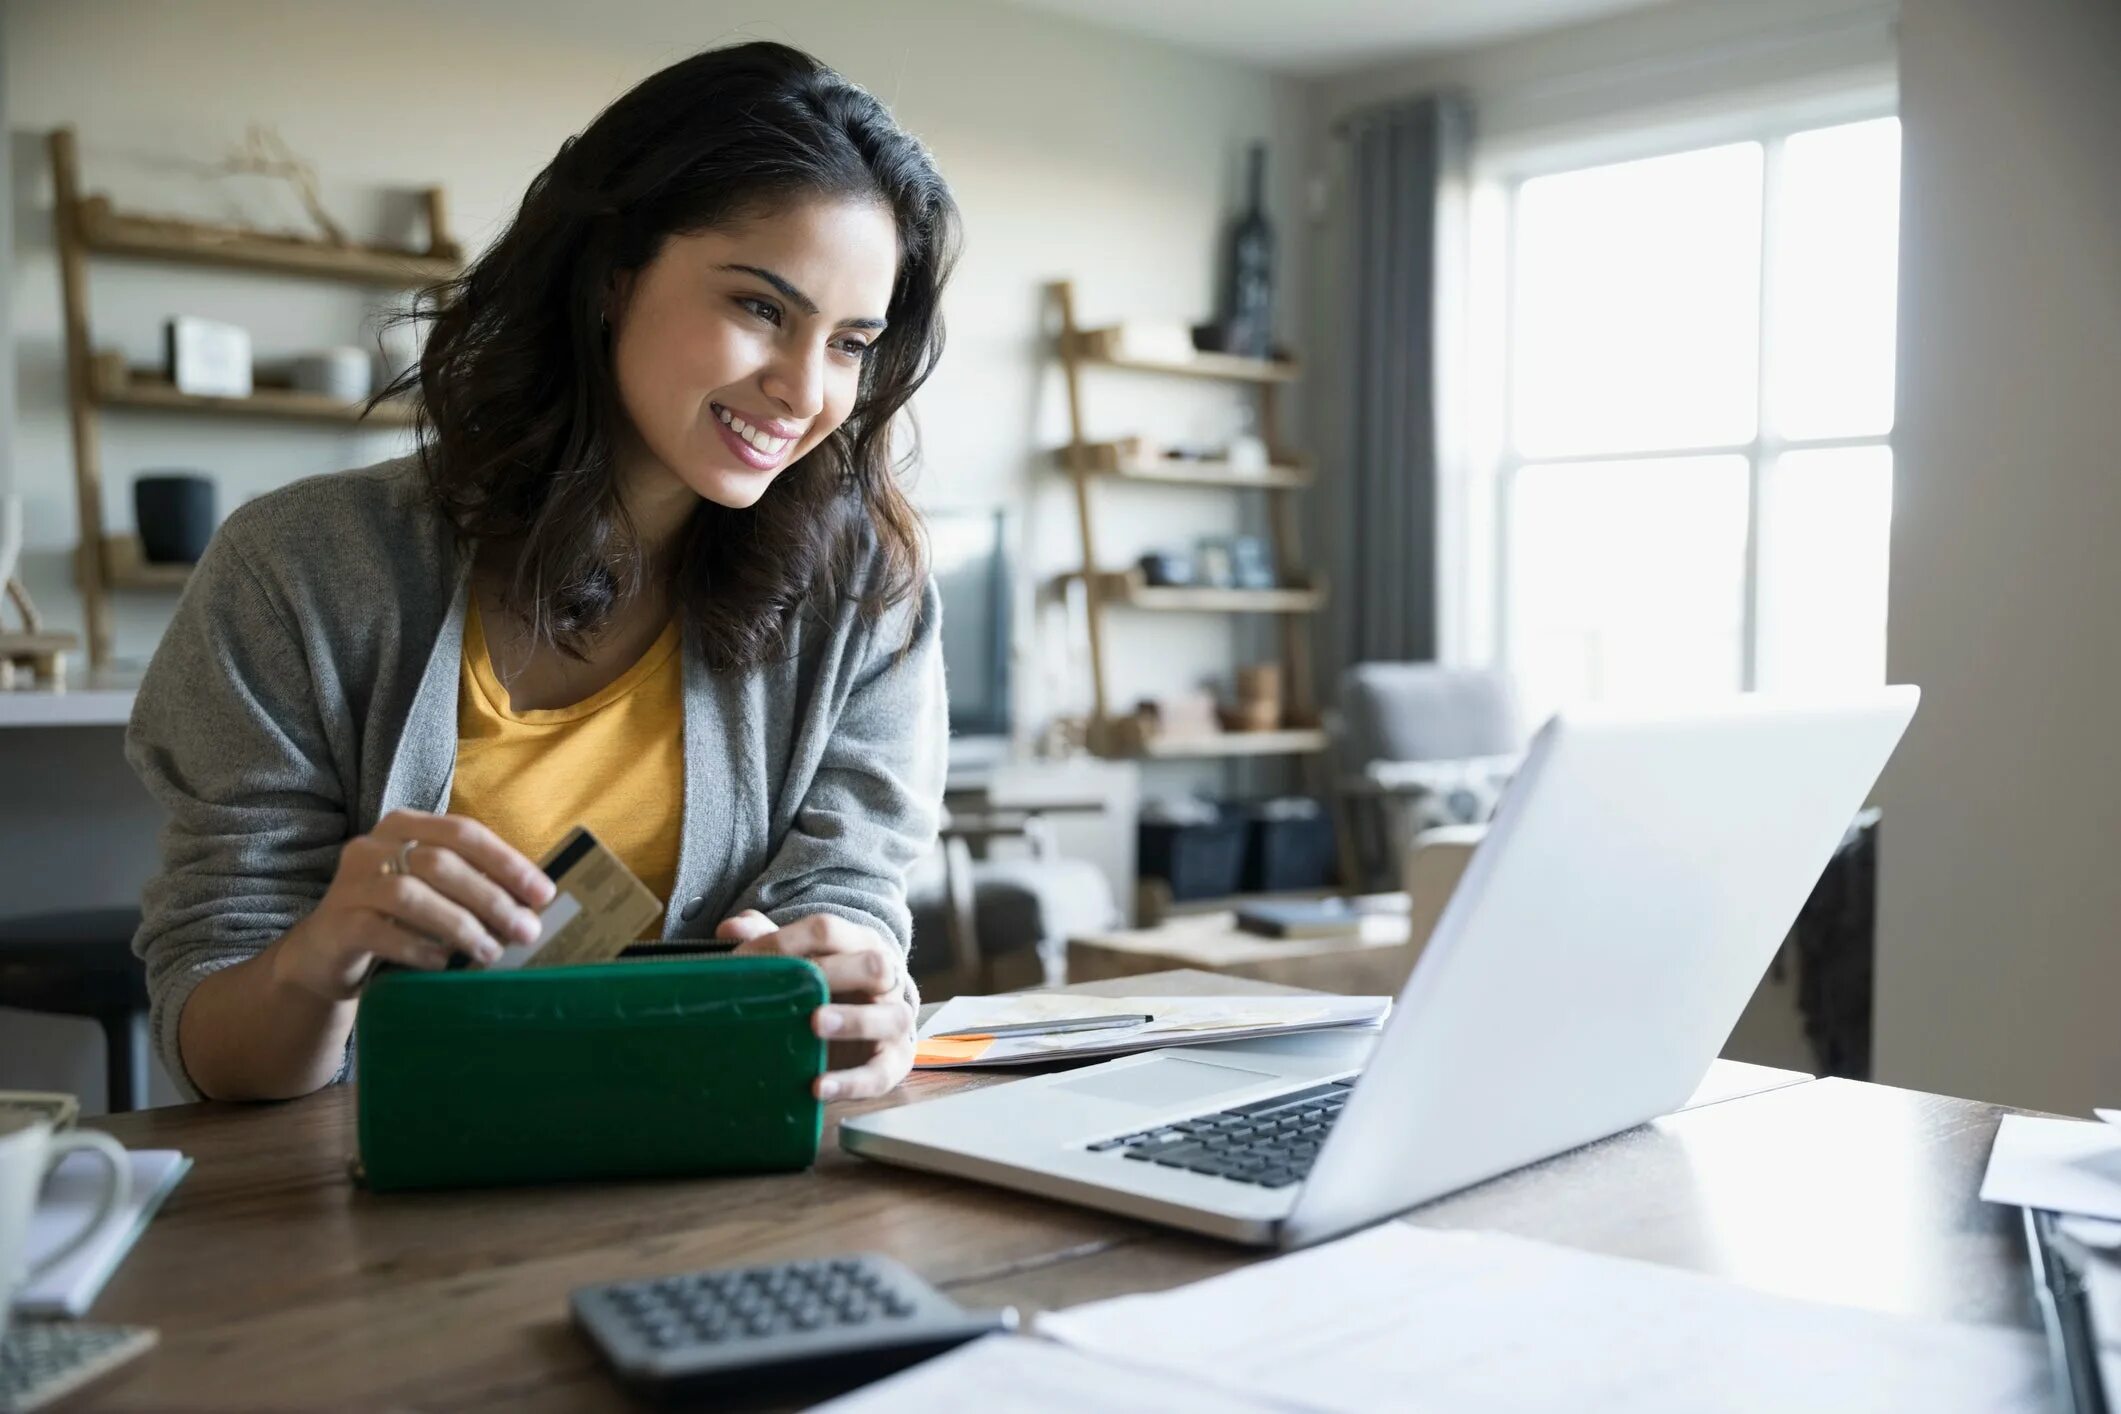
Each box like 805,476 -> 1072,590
1067,912 -> 1421,996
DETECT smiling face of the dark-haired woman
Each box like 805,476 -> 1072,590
611,199 -> 899,534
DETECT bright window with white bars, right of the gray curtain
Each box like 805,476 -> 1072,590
1476,117 -> 1900,721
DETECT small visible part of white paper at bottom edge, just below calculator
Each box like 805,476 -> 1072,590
817,1336 -> 1290,1414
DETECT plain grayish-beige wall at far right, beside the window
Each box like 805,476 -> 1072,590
1877,0 -> 2121,1113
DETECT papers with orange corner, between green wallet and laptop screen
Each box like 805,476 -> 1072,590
914,992 -> 1391,1071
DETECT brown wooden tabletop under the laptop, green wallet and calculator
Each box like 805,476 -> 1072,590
70,973 -> 2034,1410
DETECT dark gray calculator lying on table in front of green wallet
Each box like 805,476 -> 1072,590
571,1253 -> 1016,1395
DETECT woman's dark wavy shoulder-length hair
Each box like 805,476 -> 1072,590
378,42 -> 959,672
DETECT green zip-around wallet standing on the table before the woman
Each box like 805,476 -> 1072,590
354,958 -> 825,1189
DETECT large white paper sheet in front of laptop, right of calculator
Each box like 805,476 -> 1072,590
1037,1223 -> 2049,1414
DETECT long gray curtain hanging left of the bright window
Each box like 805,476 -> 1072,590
1332,93 -> 1470,664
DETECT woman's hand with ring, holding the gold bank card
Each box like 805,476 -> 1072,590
271,810 -> 554,1001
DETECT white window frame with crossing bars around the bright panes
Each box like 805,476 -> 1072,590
1436,83 -> 1898,691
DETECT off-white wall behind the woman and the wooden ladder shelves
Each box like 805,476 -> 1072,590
4,0 -> 1302,750
